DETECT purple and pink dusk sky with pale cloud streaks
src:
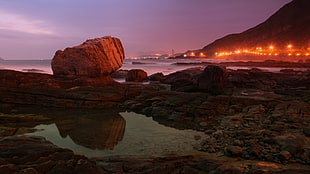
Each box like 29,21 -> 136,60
0,0 -> 291,59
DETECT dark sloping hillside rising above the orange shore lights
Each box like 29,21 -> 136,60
184,0 -> 310,56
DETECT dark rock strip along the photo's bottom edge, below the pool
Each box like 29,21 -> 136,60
0,137 -> 309,174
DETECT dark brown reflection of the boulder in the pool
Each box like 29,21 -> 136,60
56,115 -> 126,150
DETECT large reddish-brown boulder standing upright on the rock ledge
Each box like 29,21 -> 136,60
51,36 -> 125,78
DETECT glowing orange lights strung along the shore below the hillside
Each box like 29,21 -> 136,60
183,44 -> 310,57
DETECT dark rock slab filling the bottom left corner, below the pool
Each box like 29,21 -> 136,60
0,137 -> 105,174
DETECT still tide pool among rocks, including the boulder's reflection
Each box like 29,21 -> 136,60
25,112 -> 204,157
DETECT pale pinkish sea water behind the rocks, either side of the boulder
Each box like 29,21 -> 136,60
0,58 -> 305,75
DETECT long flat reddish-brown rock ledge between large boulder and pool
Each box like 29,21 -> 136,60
0,70 -> 139,108
